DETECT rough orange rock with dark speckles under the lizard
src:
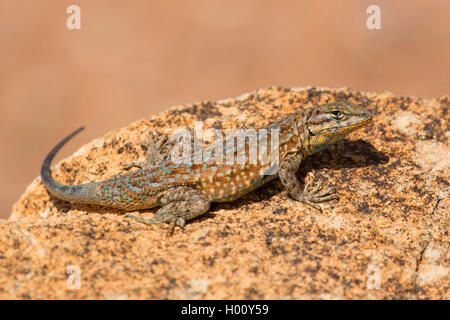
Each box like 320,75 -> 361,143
0,87 -> 450,299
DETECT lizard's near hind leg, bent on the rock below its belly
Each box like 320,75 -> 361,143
125,186 -> 210,235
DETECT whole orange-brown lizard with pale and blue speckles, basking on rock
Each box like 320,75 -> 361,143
41,101 -> 372,235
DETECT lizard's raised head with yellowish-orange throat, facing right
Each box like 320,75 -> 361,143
306,101 -> 372,154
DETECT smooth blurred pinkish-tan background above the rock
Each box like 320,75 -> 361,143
0,0 -> 450,218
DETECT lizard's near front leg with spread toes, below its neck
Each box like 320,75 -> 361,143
278,155 -> 338,210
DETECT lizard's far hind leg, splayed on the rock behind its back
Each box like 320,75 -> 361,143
121,133 -> 168,170
